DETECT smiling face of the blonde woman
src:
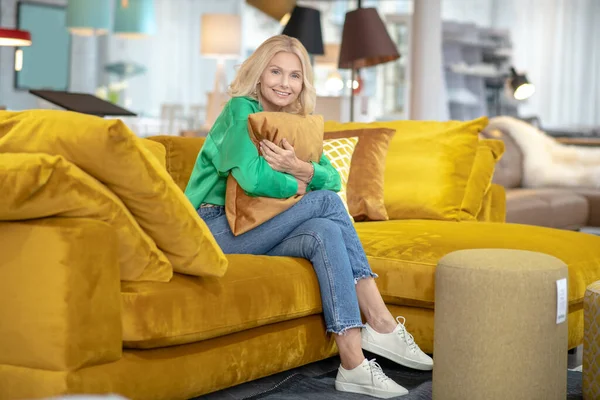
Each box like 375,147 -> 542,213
260,51 -> 303,111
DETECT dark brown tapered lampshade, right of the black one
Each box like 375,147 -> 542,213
338,8 -> 400,69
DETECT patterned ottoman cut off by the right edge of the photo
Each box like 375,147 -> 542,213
583,281 -> 600,400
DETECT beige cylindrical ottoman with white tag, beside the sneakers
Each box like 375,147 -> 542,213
433,249 -> 568,400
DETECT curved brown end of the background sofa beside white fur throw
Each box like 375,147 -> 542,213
481,128 -> 523,189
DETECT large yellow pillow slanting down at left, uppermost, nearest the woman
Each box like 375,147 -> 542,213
0,110 -> 227,276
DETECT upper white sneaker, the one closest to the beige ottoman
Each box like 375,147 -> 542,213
361,317 -> 433,371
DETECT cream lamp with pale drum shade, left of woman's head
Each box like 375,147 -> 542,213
200,14 -> 242,128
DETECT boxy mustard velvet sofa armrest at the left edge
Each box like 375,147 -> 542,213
0,218 -> 122,370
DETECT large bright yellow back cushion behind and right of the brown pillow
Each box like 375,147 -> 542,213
325,117 -> 488,221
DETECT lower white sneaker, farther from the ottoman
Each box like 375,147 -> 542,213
335,358 -> 408,399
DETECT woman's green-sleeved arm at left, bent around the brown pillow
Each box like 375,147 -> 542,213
213,99 -> 298,198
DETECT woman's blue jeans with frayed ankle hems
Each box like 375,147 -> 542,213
198,190 -> 377,334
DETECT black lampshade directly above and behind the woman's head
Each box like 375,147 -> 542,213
282,6 -> 325,55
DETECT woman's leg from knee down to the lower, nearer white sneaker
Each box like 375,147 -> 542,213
268,218 -> 408,398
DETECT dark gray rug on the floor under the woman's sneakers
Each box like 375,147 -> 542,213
196,354 -> 583,400
